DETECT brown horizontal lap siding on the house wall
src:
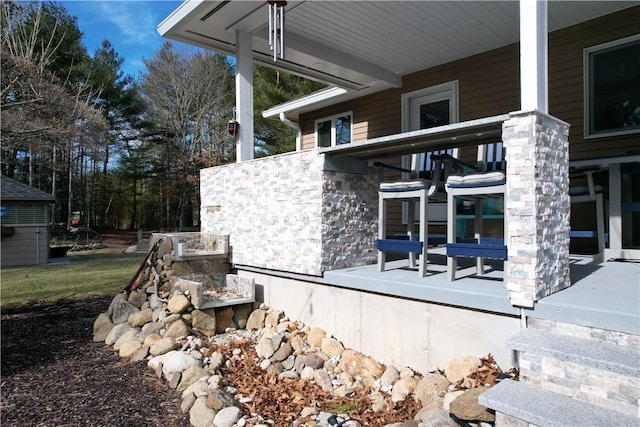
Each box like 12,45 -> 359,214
301,7 -> 640,237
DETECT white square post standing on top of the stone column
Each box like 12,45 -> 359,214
520,0 -> 549,113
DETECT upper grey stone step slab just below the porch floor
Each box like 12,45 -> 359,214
506,328 -> 640,378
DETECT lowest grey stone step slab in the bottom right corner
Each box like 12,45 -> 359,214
478,380 -> 640,427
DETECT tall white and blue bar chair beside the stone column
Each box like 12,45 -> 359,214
446,142 -> 507,281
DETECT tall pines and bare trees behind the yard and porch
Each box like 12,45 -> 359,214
0,0 -> 322,230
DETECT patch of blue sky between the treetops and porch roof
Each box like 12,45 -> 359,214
60,0 -> 182,77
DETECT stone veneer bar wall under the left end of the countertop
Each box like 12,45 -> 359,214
200,150 -> 377,276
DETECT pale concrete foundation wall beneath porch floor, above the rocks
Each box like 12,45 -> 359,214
238,271 -> 520,372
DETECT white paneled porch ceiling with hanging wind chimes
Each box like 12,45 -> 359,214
158,0 -> 640,92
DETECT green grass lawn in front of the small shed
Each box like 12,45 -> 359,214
0,253 -> 146,307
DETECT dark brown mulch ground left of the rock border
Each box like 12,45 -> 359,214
0,296 -> 190,427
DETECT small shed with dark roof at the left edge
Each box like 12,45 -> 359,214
0,175 -> 55,267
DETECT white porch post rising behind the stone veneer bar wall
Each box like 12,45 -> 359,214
236,31 -> 253,162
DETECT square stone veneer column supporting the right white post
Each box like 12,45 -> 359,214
502,111 -> 571,307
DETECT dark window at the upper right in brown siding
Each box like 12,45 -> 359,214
584,34 -> 640,138
